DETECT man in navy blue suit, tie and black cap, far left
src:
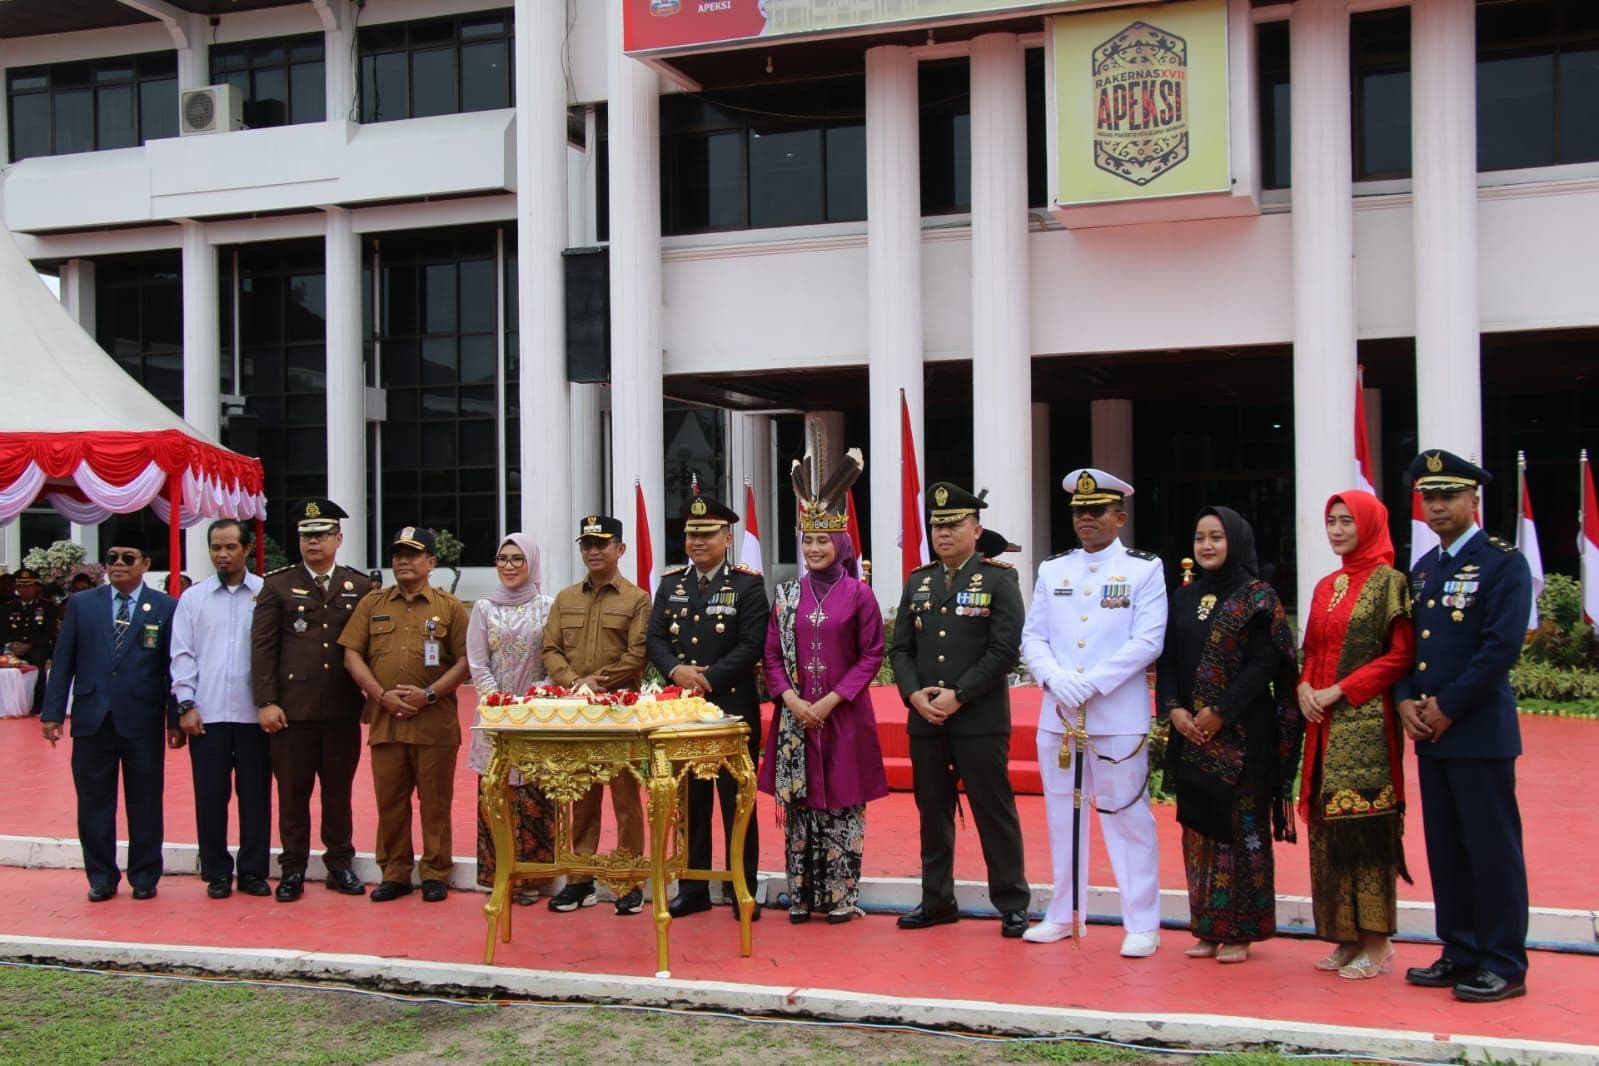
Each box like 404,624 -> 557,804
40,529 -> 184,903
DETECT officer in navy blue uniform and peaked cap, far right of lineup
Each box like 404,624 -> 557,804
1396,451 -> 1532,1002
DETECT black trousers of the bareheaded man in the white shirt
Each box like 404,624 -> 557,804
189,722 -> 272,882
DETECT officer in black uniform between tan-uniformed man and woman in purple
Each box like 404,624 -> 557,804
646,495 -> 771,919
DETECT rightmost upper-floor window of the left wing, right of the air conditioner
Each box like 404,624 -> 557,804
360,11 -> 512,121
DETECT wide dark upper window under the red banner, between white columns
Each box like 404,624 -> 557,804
658,75 -> 867,233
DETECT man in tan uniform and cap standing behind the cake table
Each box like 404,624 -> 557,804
544,515 -> 649,914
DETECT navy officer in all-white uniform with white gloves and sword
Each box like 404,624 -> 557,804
1022,467 -> 1166,959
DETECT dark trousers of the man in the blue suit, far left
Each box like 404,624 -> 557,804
72,714 -> 166,889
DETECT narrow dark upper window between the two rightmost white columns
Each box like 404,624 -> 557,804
1350,8 -> 1410,181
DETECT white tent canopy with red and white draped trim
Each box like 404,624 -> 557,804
0,227 -> 267,558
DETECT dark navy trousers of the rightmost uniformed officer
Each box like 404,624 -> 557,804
1417,758 -> 1527,981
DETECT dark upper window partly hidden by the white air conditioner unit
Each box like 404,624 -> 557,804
211,34 -> 328,129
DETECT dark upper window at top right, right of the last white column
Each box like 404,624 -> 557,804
1477,0 -> 1599,171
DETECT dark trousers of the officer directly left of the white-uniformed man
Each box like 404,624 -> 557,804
910,734 -> 1033,913
